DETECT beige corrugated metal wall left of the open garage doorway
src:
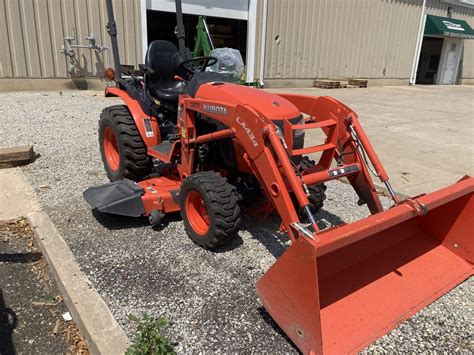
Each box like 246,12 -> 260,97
0,0 -> 142,78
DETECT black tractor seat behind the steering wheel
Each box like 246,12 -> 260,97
145,40 -> 187,101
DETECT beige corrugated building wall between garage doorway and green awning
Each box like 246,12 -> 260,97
264,0 -> 474,85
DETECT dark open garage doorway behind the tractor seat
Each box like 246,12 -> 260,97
147,10 -> 247,62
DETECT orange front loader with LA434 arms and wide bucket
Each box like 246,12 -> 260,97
175,90 -> 474,354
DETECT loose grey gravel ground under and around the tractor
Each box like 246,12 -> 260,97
0,91 -> 474,353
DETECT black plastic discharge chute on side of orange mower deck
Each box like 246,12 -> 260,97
83,180 -> 145,217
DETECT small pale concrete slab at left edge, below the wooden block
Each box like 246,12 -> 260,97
0,168 -> 41,223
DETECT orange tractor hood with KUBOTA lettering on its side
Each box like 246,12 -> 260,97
195,82 -> 301,120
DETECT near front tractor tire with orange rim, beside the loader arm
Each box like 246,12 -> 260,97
180,171 -> 240,249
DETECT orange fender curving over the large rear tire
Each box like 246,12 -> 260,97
105,87 -> 161,148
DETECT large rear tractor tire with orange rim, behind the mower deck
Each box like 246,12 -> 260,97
99,105 -> 152,181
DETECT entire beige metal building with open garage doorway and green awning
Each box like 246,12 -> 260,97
0,0 -> 474,90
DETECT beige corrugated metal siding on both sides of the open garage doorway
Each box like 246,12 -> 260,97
0,0 -> 474,86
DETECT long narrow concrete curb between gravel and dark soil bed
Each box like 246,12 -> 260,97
28,211 -> 130,355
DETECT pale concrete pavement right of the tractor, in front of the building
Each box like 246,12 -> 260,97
269,86 -> 474,196
